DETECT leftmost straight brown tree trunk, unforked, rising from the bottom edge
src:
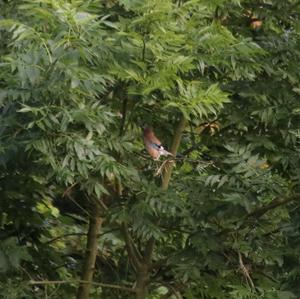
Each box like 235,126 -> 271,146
76,204 -> 103,299
